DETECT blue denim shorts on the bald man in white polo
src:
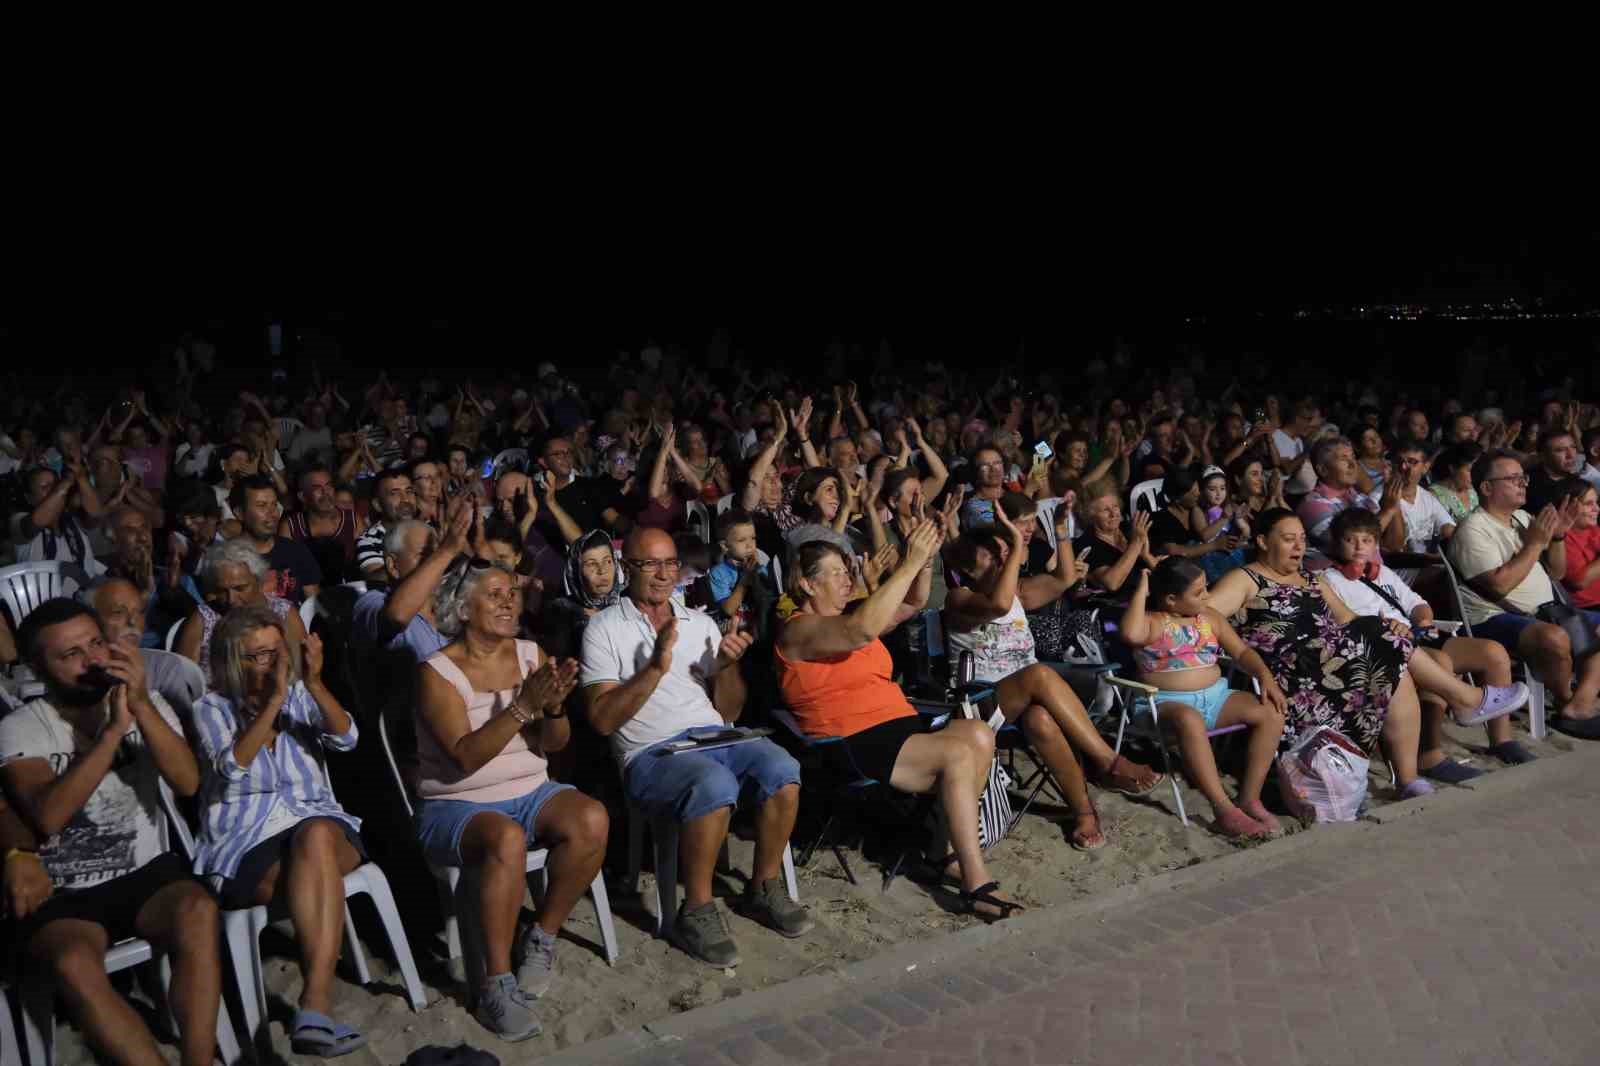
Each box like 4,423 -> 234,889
622,730 -> 800,821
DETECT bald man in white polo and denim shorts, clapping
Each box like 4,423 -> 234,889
581,528 -> 811,967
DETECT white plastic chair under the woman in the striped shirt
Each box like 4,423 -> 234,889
162,767 -> 427,1045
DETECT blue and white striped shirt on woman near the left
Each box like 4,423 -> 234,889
194,682 -> 362,877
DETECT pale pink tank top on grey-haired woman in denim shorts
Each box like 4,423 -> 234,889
416,640 -> 549,804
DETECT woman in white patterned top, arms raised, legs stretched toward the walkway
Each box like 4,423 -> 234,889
944,507 -> 1162,850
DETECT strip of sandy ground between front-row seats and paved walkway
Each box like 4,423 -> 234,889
58,710 -> 1581,1066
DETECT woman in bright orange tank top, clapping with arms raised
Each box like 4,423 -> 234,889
774,520 -> 1021,920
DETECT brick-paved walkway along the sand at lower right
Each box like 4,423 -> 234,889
566,746 -> 1600,1066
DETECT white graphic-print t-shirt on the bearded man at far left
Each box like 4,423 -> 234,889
0,691 -> 182,890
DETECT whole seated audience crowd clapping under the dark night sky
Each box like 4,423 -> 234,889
0,344 -> 1600,1066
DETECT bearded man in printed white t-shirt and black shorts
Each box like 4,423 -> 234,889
0,599 -> 222,1066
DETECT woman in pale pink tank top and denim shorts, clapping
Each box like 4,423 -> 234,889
416,560 -> 610,1040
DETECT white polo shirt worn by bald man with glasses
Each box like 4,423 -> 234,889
579,597 -> 726,767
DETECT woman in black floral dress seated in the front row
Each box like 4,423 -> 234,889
1211,509 -> 1434,799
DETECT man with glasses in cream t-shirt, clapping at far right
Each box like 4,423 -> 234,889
1448,451 -> 1600,739
